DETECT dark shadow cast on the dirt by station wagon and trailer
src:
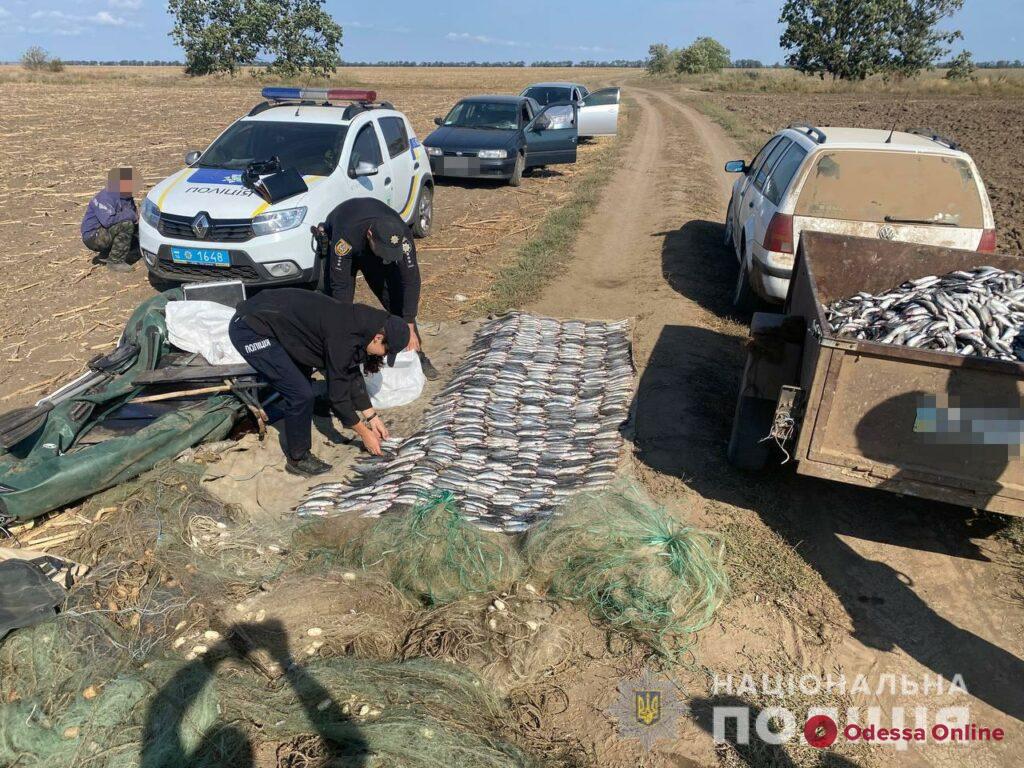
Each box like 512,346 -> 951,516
632,221 -> 1024,719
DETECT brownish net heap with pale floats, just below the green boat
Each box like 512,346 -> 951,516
61,462 -> 284,659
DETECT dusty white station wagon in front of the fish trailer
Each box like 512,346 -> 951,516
725,124 -> 995,308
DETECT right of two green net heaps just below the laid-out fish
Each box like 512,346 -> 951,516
525,484 -> 728,659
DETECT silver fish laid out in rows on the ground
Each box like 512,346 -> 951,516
296,312 -> 634,532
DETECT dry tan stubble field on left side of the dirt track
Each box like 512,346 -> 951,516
0,67 -> 638,411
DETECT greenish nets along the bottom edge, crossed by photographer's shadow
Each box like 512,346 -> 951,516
0,616 -> 538,768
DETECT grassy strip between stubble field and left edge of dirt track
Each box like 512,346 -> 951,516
477,99 -> 636,314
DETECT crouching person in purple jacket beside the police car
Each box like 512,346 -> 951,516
82,168 -> 138,272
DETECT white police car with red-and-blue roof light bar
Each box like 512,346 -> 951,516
139,88 -> 433,286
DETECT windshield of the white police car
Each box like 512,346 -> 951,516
199,120 -> 346,176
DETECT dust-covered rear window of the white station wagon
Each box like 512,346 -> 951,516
796,150 -> 985,229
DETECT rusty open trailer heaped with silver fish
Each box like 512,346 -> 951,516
729,232 -> 1024,515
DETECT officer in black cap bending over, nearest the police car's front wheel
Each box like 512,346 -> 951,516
313,198 -> 438,381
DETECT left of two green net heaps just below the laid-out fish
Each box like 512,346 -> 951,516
303,490 -> 519,606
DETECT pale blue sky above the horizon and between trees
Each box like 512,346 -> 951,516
0,0 -> 1024,63
